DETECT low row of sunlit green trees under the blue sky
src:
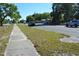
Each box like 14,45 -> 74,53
26,13 -> 51,22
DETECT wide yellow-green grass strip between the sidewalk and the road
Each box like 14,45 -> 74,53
18,24 -> 79,56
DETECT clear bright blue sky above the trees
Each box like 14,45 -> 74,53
15,3 -> 52,20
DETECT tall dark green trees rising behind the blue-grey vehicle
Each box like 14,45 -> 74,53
50,3 -> 79,24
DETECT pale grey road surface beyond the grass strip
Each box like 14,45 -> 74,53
33,25 -> 79,37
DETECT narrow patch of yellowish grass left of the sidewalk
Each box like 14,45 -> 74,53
0,25 -> 13,56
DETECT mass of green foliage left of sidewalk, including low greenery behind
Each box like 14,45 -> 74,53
0,3 -> 21,26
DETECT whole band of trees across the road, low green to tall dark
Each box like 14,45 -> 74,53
26,3 -> 79,25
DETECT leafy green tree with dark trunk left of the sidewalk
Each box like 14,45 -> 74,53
0,3 -> 19,26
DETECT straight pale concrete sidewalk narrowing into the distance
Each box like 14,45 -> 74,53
4,24 -> 39,56
